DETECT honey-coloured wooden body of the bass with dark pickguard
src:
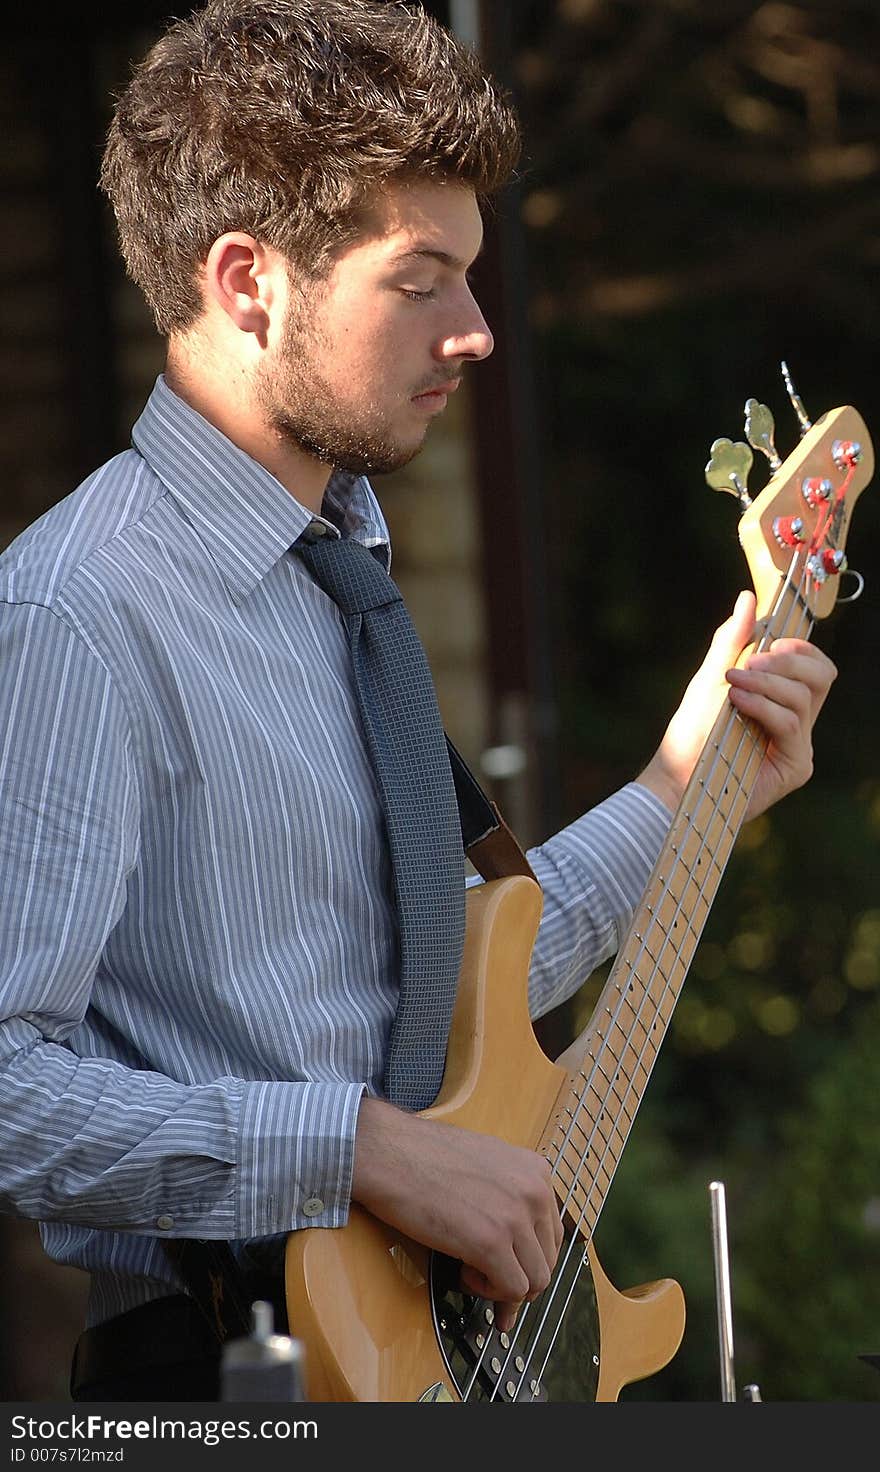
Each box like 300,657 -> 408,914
285,876 -> 684,1401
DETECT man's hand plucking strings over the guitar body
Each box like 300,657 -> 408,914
352,1098 -> 562,1329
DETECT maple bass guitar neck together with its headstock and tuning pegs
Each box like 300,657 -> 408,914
540,403 -> 874,1239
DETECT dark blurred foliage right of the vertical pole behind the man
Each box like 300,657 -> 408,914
514,0 -> 880,1401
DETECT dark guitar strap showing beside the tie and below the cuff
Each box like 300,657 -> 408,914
162,736 -> 537,1344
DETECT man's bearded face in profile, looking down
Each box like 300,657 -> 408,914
259,184 -> 493,474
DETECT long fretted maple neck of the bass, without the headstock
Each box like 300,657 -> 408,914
543,583 -> 803,1239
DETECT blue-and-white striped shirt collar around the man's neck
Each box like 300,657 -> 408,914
131,374 -> 390,601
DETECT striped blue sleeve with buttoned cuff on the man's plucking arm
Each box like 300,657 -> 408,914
0,605 -> 363,1238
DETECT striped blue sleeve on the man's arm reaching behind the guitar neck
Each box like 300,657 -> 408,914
528,782 -> 673,1019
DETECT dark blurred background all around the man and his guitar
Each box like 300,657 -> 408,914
0,0 -> 880,1401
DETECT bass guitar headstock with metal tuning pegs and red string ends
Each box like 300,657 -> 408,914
706,365 -> 874,618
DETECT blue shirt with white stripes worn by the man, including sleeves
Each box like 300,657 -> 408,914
0,377 -> 668,1323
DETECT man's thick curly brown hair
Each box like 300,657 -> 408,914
100,0 -> 519,334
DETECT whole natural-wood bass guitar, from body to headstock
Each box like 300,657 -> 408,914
285,379 -> 874,1401
